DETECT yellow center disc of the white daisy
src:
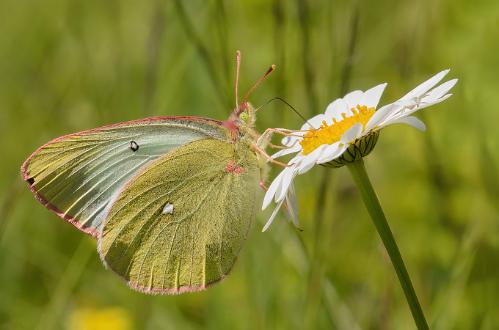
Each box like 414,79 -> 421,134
300,105 -> 376,155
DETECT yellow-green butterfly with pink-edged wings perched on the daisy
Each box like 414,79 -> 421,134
21,51 -> 290,294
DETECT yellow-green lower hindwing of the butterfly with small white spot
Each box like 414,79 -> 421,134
98,139 -> 259,294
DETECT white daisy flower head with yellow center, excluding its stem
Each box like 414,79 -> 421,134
262,70 -> 457,231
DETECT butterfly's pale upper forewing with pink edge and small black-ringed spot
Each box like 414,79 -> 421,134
21,117 -> 228,236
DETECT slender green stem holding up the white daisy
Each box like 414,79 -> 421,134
348,159 -> 428,329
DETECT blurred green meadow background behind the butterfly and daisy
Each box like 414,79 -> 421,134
0,0 -> 499,330
